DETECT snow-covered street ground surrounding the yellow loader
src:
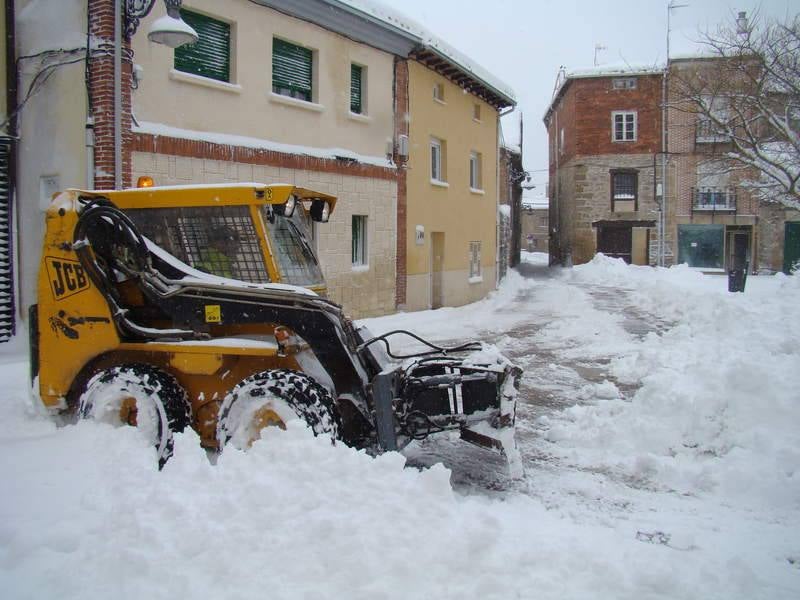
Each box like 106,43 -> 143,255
0,254 -> 800,600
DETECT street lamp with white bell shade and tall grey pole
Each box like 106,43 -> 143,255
114,0 -> 198,189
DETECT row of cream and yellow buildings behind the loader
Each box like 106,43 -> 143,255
9,0 -> 513,332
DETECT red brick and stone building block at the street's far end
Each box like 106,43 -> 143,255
544,57 -> 800,273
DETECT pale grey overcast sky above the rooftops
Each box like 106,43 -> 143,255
394,0 -> 800,190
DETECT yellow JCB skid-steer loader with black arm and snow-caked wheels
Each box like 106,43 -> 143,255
31,183 -> 519,470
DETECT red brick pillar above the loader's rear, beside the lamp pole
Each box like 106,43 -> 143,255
89,0 -> 133,189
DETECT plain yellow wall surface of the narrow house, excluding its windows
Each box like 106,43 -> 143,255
407,61 -> 497,308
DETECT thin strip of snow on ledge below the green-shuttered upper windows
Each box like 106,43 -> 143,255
131,121 -> 395,169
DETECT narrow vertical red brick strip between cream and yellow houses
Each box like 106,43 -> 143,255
394,58 -> 408,306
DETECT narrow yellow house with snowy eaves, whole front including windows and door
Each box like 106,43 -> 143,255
405,55 -> 514,310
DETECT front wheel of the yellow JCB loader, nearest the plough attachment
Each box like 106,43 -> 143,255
217,369 -> 339,450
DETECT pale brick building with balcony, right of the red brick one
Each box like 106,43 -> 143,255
667,57 -> 800,273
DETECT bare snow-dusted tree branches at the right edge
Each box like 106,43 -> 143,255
671,13 -> 800,209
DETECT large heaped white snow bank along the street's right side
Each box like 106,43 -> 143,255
543,256 -> 800,507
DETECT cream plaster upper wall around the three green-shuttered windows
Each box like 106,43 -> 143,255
133,0 -> 394,158
